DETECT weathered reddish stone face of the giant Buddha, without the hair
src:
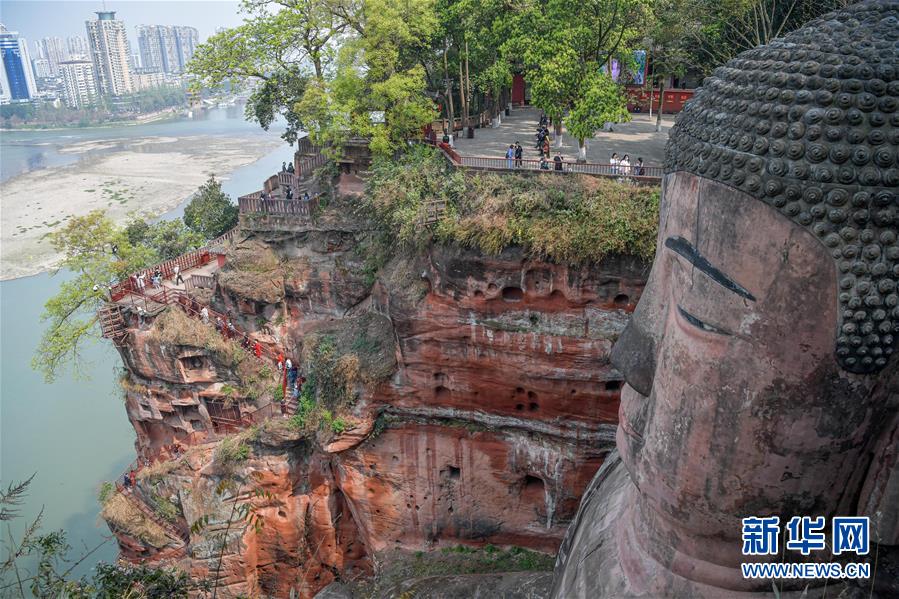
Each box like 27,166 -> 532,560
613,173 -> 899,548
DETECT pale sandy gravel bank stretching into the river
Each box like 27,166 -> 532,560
0,123 -> 289,280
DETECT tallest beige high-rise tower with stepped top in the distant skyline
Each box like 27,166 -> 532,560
85,11 -> 134,96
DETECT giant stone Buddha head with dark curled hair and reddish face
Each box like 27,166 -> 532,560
560,1 -> 899,594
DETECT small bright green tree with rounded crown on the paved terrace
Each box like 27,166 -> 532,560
565,73 -> 630,162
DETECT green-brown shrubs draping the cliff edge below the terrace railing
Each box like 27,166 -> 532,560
363,147 -> 659,264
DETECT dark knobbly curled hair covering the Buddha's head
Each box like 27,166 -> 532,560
665,0 -> 899,373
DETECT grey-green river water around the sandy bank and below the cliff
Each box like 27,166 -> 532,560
0,108 -> 291,580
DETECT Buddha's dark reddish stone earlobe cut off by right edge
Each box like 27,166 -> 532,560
858,364 -> 899,545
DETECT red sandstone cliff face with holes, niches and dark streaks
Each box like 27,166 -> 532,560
104,199 -> 645,597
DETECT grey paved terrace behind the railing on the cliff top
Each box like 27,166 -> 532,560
456,107 -> 674,166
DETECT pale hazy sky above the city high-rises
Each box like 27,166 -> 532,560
0,0 -> 241,44
